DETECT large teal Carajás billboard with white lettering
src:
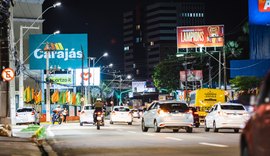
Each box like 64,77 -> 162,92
29,34 -> 88,70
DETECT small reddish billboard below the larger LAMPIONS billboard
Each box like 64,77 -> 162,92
180,70 -> 203,82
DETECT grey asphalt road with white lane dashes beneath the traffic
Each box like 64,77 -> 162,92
44,119 -> 240,156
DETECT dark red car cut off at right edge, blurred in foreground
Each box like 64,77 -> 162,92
240,73 -> 270,156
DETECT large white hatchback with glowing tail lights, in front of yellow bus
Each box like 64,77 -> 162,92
141,100 -> 193,133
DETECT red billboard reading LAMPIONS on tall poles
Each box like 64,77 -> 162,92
177,25 -> 224,49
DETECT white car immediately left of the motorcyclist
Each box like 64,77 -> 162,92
80,104 -> 95,126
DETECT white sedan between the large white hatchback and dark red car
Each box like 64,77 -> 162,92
204,103 -> 250,133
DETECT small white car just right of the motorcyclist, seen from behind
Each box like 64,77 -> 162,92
110,106 -> 133,125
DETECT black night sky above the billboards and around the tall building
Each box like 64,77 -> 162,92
43,0 -> 248,68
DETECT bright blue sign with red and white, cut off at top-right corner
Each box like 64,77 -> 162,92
248,0 -> 270,25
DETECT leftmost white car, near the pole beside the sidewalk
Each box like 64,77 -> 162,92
16,107 -> 39,125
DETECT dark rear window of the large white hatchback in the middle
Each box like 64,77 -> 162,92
160,103 -> 188,112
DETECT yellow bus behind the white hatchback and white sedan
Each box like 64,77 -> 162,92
189,88 -> 225,122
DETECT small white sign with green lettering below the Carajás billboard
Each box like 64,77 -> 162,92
44,74 -> 73,89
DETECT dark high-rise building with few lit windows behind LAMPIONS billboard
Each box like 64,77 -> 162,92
123,2 -> 205,80
